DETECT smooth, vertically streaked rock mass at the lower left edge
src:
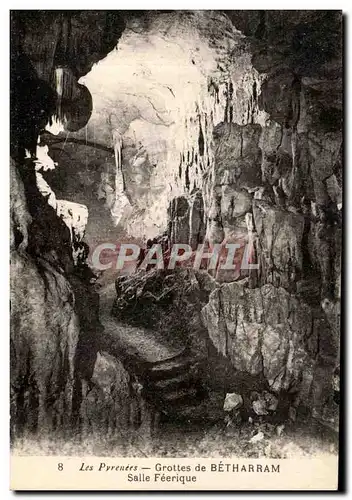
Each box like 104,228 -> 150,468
10,164 -> 79,436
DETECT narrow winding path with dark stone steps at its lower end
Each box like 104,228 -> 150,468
100,284 -> 212,419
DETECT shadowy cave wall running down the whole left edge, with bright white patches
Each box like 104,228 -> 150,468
10,11 -> 127,439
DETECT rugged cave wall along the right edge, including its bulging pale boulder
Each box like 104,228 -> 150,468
204,12 -> 342,427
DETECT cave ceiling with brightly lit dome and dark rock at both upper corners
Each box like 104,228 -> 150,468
13,11 -> 342,152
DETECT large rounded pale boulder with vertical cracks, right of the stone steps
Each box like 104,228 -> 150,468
202,283 -> 320,400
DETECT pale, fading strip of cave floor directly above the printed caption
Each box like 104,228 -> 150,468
12,421 -> 339,459
